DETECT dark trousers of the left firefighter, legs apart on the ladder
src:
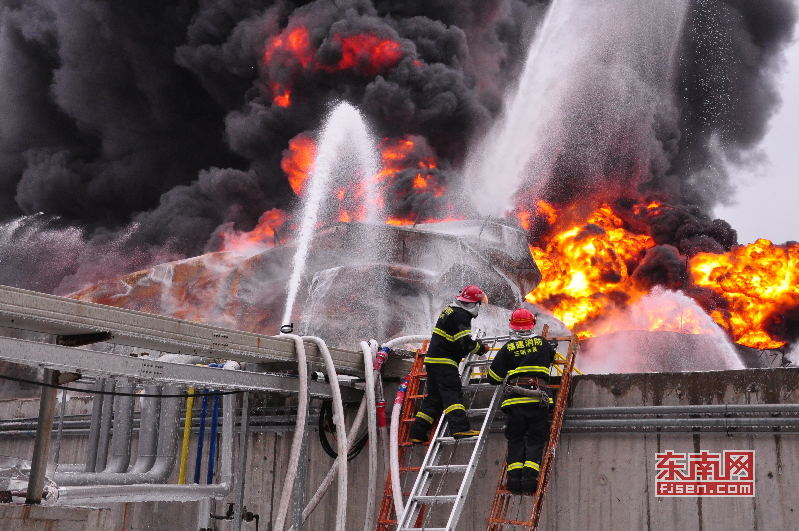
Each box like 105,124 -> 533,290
411,363 -> 469,441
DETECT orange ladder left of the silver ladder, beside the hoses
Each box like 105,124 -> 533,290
375,341 -> 429,531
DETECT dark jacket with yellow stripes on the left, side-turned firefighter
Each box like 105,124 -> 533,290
424,306 -> 481,367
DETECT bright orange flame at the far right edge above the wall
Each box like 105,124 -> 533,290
689,239 -> 799,349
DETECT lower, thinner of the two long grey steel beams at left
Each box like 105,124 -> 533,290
0,337 -> 361,400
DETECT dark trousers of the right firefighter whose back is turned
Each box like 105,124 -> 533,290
502,404 -> 550,477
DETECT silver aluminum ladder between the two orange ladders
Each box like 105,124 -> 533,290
397,338 -> 503,531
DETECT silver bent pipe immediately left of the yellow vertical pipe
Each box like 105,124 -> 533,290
55,385 -> 182,486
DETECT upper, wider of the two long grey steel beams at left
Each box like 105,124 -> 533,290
0,286 -> 409,376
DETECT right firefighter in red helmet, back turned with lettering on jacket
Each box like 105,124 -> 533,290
488,308 -> 556,494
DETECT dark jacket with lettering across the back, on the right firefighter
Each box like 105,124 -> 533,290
488,336 -> 556,408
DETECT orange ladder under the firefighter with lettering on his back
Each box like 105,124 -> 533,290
487,334 -> 578,531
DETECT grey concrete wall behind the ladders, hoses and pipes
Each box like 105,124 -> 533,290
0,369 -> 799,531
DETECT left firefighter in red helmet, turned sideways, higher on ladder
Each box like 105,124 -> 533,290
411,285 -> 488,444
